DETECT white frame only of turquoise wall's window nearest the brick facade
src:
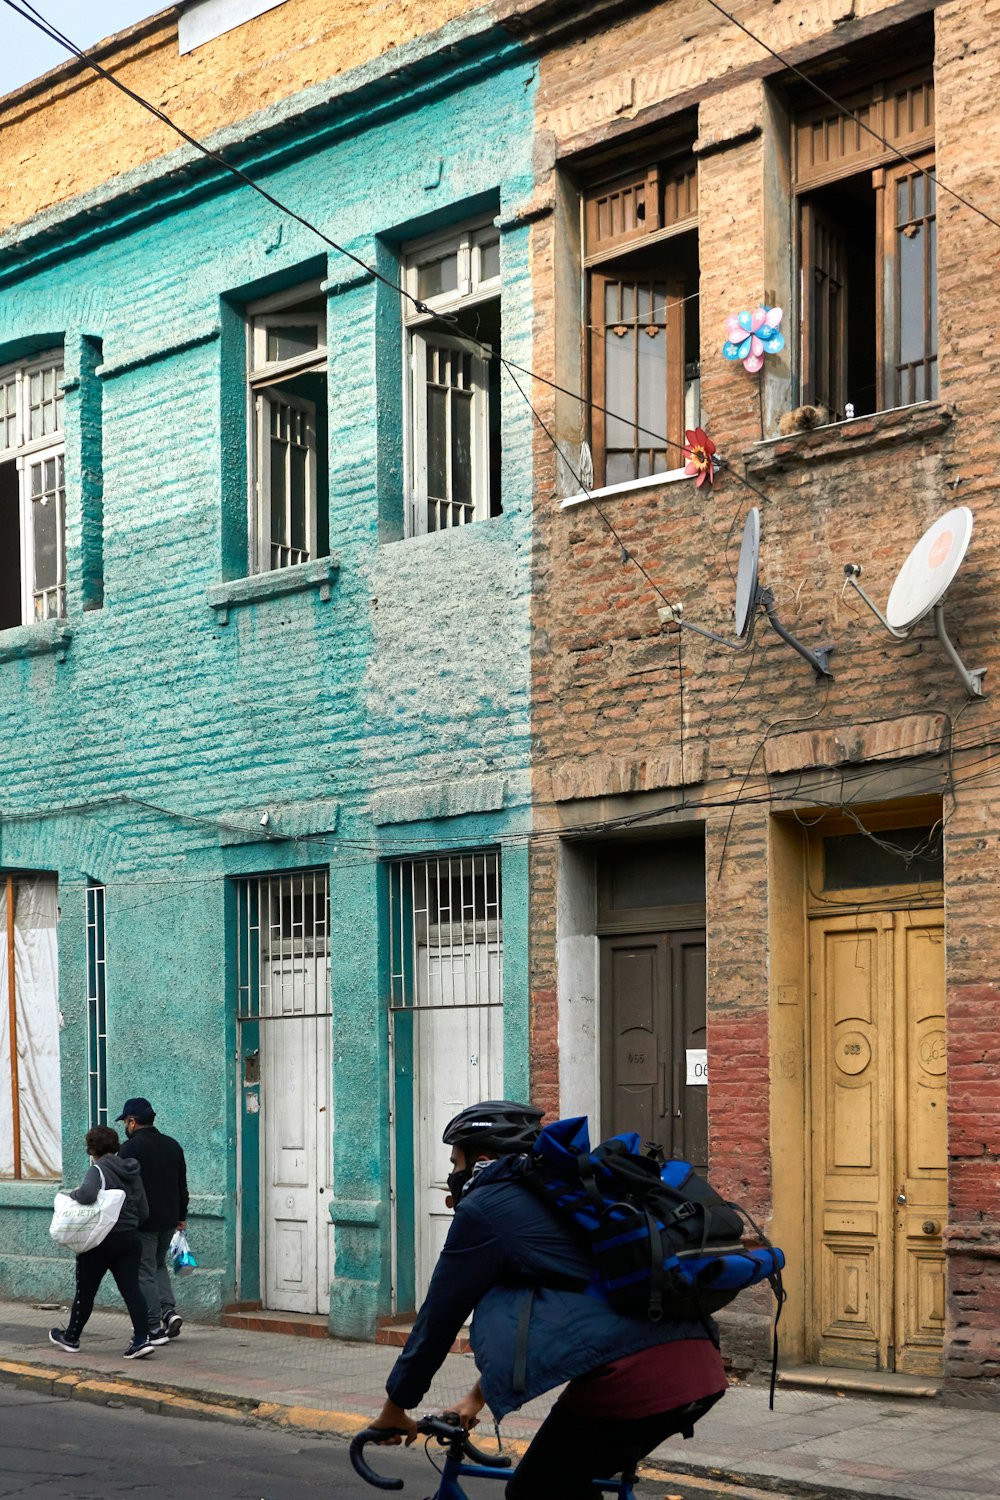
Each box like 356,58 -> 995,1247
403,219 -> 501,536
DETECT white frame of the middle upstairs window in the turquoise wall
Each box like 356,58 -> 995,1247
246,282 -> 327,573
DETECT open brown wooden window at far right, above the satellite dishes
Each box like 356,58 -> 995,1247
795,65 -> 937,419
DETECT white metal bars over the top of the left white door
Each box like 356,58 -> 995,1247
237,870 -> 331,1022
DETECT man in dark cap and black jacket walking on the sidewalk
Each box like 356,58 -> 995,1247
118,1098 -> 187,1344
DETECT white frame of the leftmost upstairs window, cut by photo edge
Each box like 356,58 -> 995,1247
0,350 -> 66,626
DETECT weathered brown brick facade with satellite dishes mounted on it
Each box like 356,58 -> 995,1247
531,0 -> 1000,1401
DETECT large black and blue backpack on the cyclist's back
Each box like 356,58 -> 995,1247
523,1116 -> 784,1392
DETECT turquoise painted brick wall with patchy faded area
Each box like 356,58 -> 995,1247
0,21 -> 535,1334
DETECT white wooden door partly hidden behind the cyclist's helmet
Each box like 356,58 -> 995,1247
414,941 -> 504,1307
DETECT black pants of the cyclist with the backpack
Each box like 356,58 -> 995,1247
505,1391 -> 723,1500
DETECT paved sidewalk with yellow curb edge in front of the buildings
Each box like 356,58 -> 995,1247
0,1302 -> 1000,1500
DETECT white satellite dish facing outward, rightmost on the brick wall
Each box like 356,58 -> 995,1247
844,506 -> 987,698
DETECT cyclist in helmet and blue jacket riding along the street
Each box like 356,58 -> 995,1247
372,1100 -> 726,1500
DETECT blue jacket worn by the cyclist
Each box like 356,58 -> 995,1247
385,1157 -> 709,1421
